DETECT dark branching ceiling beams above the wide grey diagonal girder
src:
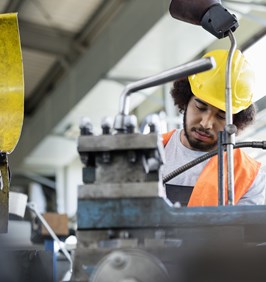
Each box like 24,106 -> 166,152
23,0 -> 129,116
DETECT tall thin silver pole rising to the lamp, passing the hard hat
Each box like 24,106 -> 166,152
225,31 -> 236,205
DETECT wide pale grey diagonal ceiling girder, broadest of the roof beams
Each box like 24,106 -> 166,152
9,0 -> 169,170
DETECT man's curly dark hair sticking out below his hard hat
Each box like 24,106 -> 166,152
170,78 -> 256,132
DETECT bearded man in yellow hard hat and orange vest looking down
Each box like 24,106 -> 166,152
163,50 -> 266,206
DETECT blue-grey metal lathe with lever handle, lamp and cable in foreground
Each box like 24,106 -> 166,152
71,0 -> 266,282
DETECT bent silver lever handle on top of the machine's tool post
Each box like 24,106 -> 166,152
114,57 -> 215,130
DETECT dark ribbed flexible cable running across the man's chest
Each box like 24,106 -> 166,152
163,141 -> 266,184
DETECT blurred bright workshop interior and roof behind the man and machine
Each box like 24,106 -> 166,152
0,0 -> 266,225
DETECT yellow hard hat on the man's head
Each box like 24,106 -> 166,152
188,50 -> 255,114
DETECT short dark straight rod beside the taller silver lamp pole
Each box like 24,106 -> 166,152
218,131 -> 225,206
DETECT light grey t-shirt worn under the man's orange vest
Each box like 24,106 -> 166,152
163,130 -> 266,205
